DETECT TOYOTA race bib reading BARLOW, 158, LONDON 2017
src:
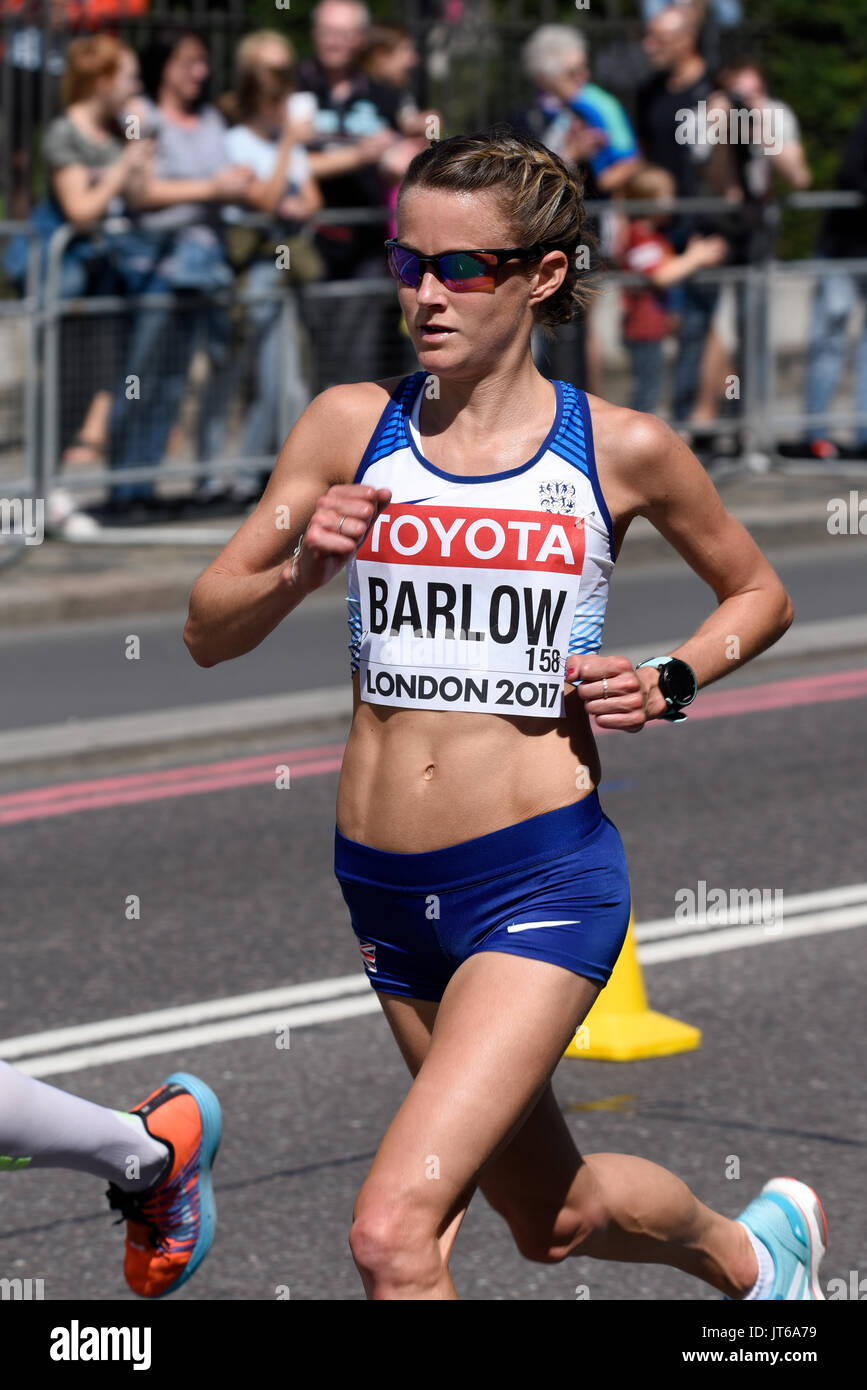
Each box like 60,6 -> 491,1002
356,503 -> 585,719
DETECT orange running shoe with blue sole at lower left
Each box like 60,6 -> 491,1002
106,1072 -> 222,1298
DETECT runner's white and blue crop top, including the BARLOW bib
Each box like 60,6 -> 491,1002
346,371 -> 614,719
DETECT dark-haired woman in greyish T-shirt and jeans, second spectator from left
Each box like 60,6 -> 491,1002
108,31 -> 253,512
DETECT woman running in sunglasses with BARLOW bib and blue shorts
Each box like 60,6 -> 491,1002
185,131 -> 825,1300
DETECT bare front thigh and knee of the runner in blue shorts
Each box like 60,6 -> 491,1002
350,951 -> 599,1300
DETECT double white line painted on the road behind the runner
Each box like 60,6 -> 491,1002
6,884 -> 867,1076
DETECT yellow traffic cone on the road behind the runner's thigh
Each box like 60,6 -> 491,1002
563,913 -> 702,1062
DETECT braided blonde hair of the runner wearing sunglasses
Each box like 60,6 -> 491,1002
397,125 -> 597,339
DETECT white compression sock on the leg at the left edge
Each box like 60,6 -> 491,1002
0,1062 -> 168,1193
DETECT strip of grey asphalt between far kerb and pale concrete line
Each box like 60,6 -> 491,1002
0,538 -> 867,730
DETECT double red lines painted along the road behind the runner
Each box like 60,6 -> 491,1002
0,667 -> 867,826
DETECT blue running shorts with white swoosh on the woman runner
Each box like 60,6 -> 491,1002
333,791 -> 629,1001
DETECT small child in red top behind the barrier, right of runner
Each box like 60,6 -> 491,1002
618,167 -> 728,410
